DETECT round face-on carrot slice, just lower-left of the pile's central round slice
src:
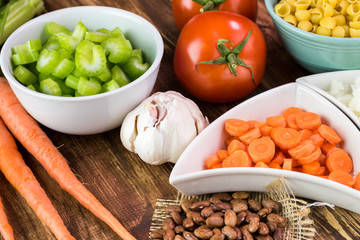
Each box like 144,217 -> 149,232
248,137 -> 275,163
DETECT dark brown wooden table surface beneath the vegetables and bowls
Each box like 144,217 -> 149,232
0,0 -> 360,240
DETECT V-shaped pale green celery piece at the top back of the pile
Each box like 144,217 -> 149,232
56,22 -> 87,51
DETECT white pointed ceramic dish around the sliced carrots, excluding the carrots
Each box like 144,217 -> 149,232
169,83 -> 360,213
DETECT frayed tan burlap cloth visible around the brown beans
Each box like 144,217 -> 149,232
150,178 -> 321,240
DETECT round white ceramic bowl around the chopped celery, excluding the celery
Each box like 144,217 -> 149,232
0,6 -> 164,134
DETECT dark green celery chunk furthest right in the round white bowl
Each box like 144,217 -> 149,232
122,49 -> 150,81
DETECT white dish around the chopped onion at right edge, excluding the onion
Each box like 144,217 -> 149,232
296,70 -> 360,129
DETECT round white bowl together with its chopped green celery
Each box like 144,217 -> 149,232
0,6 -> 164,135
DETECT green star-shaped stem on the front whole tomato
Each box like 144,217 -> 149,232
195,30 -> 256,86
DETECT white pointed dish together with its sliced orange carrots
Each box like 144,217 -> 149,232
169,83 -> 360,213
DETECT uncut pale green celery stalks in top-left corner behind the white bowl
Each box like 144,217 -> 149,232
0,0 -> 45,44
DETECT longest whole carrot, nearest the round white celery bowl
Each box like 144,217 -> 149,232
0,78 -> 135,240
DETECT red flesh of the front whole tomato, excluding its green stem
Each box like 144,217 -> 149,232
173,11 -> 266,103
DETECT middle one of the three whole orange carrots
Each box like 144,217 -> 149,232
0,119 -> 75,240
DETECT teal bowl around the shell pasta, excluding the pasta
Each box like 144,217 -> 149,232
265,0 -> 360,73
